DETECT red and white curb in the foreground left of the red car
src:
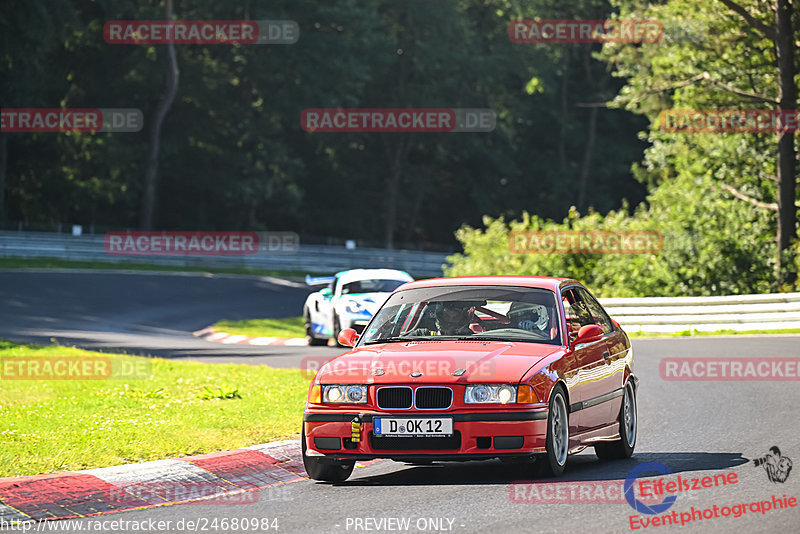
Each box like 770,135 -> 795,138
0,440 -> 371,525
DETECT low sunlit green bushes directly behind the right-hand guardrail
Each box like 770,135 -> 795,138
445,177 -> 777,297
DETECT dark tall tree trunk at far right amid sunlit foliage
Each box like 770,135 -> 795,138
775,0 -> 797,285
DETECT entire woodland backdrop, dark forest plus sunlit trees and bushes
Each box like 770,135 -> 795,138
0,0 -> 800,296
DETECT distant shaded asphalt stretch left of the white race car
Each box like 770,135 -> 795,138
0,270 -> 342,367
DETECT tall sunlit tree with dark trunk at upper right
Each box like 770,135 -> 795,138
603,0 -> 797,288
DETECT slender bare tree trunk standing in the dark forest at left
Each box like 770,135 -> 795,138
139,0 -> 180,230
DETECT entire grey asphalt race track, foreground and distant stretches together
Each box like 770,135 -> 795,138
0,272 -> 800,534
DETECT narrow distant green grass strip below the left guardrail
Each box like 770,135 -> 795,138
0,257 -> 312,278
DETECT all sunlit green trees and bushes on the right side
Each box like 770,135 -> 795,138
448,0 -> 800,297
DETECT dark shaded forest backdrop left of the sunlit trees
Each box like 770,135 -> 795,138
0,0 -> 645,246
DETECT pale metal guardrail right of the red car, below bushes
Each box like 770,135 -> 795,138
600,293 -> 800,333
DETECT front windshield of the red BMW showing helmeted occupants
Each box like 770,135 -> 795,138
359,286 -> 561,345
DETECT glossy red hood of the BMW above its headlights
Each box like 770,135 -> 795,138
317,341 -> 562,384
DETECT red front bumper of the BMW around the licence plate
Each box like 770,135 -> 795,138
303,408 -> 548,460
